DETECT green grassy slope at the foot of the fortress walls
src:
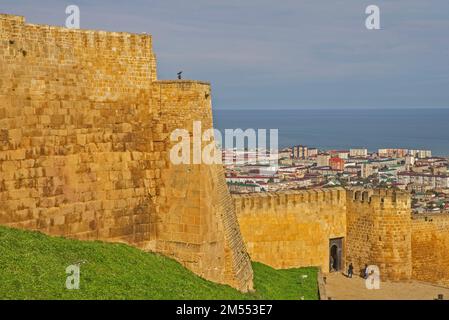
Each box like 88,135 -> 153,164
0,226 -> 317,299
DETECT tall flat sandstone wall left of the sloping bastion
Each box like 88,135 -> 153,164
0,15 -> 158,246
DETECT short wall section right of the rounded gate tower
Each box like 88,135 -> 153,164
411,214 -> 449,286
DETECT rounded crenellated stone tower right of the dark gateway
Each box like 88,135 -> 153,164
346,190 -> 412,280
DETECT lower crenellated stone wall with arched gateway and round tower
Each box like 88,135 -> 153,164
233,188 -> 449,285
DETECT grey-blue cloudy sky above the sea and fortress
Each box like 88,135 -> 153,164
0,0 -> 449,109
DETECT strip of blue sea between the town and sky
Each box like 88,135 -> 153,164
214,108 -> 449,156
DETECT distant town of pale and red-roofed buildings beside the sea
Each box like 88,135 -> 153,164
222,145 -> 449,213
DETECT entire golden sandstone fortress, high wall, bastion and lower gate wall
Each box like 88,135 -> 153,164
0,15 -> 449,291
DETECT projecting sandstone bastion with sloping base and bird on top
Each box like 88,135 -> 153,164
152,81 -> 253,290
